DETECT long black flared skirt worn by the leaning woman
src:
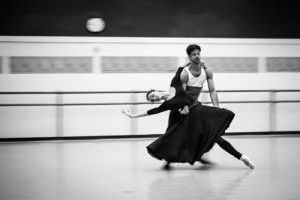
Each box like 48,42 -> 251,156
147,103 -> 235,165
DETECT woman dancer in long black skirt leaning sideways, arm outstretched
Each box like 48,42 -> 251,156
122,67 -> 255,169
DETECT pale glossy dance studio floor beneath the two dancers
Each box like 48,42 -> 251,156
0,135 -> 300,200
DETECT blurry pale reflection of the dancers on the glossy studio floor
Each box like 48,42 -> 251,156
148,166 -> 255,200
